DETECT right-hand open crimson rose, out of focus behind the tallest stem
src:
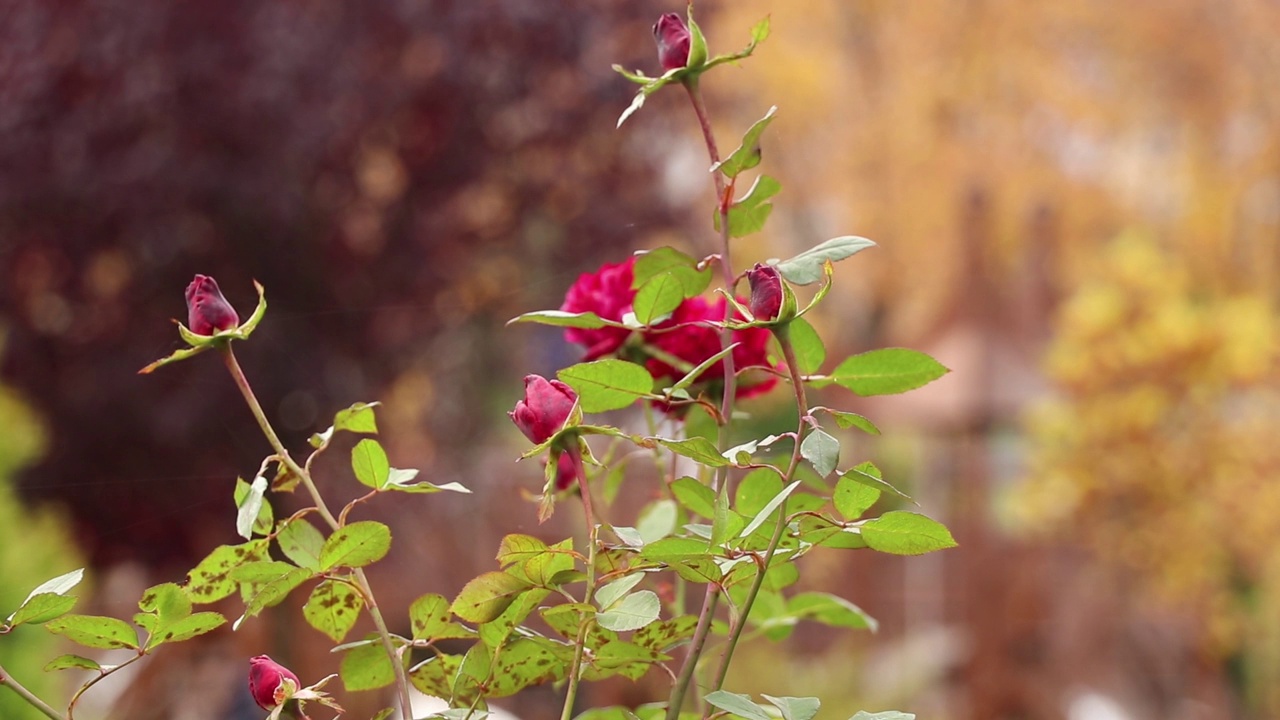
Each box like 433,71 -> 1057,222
645,297 -> 778,397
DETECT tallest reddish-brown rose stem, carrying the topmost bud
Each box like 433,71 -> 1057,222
667,77 -> 737,720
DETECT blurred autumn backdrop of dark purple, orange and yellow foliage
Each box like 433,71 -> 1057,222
0,0 -> 1280,720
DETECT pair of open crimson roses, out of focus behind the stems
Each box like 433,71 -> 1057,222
561,258 -> 778,397
